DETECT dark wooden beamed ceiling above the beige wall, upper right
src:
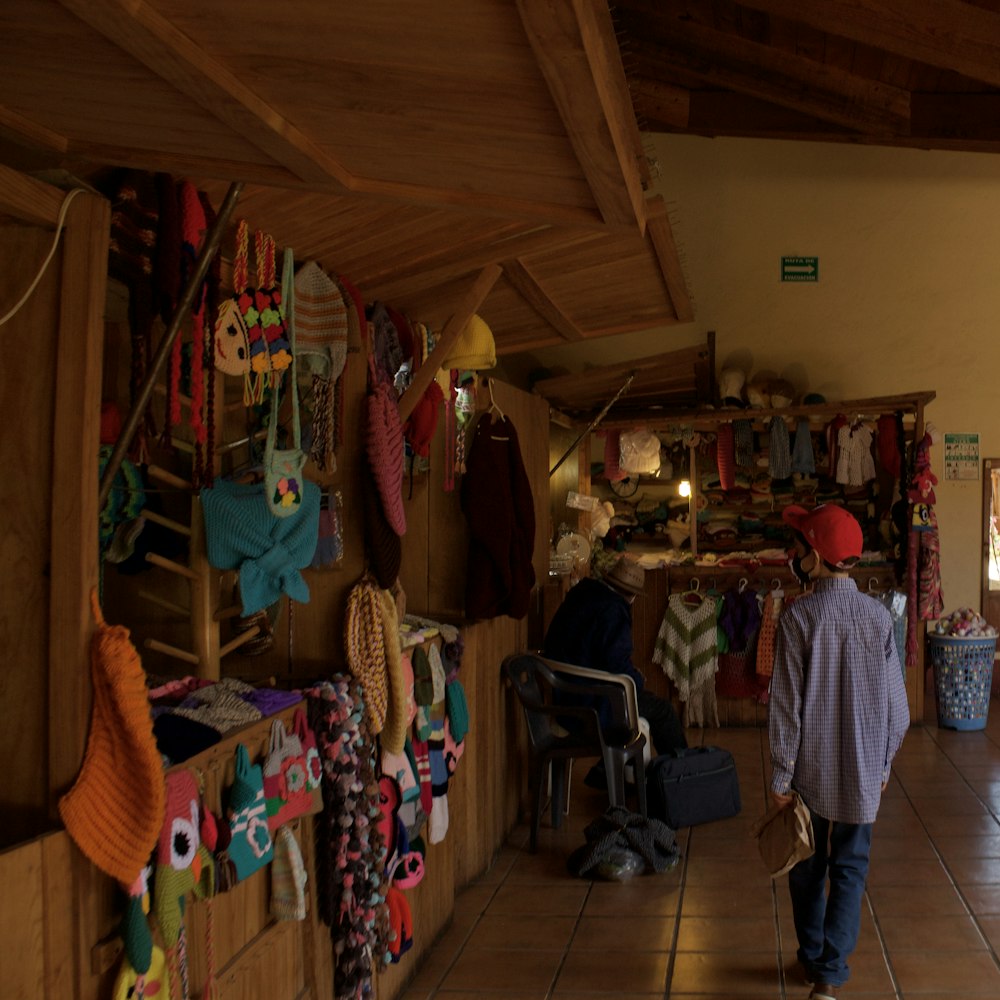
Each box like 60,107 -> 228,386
615,0 -> 1000,152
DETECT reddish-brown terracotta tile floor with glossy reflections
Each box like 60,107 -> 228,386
402,689 -> 1000,1000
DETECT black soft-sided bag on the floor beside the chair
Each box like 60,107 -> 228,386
646,747 -> 741,830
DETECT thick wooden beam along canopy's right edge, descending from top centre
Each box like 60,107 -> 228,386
517,0 -> 647,230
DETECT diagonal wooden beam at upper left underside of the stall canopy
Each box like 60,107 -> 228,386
59,0 -> 352,190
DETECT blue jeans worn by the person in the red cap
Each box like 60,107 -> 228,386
788,813 -> 872,986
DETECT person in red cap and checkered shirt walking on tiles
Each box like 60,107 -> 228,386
769,504 -> 909,1000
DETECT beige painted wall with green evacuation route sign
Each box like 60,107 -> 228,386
516,136 -> 1000,610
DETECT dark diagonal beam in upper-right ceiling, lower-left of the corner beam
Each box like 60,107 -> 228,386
630,19 -> 910,135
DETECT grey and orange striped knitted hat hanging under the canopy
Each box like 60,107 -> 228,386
295,260 -> 347,379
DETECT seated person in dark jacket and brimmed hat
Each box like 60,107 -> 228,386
542,558 -> 687,784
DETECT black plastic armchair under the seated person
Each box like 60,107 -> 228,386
500,653 -> 647,852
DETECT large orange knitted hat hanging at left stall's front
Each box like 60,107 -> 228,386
59,591 -> 165,886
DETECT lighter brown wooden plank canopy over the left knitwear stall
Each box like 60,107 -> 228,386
0,0 -> 692,372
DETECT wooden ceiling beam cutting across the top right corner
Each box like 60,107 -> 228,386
740,0 -> 1000,87
